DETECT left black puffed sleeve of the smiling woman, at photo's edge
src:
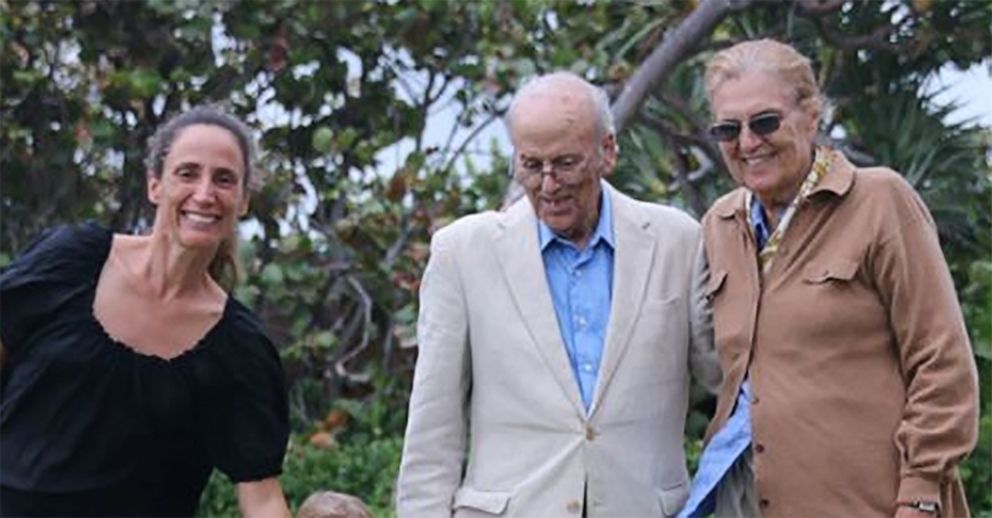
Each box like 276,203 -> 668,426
0,223 -> 111,357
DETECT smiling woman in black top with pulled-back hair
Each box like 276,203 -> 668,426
0,107 -> 289,517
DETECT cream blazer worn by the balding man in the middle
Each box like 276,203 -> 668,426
397,182 -> 720,518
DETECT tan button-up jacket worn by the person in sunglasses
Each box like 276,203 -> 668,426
703,153 -> 978,517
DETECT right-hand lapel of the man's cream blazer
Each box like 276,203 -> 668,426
589,187 -> 655,416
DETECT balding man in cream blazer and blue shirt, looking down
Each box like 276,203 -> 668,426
397,73 -> 720,517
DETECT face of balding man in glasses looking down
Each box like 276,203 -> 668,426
511,92 -> 616,248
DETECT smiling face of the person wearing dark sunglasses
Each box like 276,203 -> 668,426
712,72 -> 818,209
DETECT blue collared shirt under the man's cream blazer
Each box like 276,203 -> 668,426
537,190 -> 614,411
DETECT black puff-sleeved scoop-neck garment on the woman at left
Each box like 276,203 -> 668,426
0,224 -> 289,516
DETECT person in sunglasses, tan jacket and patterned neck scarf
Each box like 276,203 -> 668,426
683,40 -> 978,518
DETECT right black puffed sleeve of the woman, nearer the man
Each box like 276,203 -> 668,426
202,302 -> 289,483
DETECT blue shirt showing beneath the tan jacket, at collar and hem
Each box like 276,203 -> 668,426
679,196 -> 781,518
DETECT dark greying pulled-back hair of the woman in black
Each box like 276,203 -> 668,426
145,105 -> 255,292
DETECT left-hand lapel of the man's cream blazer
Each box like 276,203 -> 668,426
495,198 -> 586,417
